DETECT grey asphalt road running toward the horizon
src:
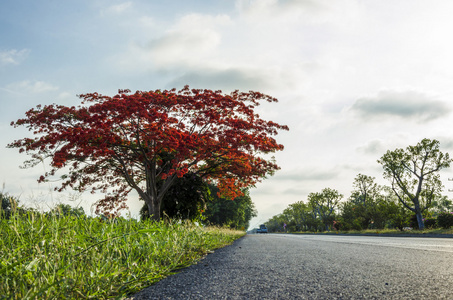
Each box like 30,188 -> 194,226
127,234 -> 453,299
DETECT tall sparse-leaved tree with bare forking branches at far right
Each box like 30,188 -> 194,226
378,139 -> 452,229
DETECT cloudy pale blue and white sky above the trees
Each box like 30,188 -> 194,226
0,0 -> 453,227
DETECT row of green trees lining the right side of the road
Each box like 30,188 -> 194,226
265,139 -> 453,232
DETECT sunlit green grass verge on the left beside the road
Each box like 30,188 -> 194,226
0,214 -> 245,299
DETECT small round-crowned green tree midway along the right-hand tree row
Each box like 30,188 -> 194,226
308,188 -> 343,230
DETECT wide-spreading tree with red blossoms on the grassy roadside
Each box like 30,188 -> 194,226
8,86 -> 288,220
